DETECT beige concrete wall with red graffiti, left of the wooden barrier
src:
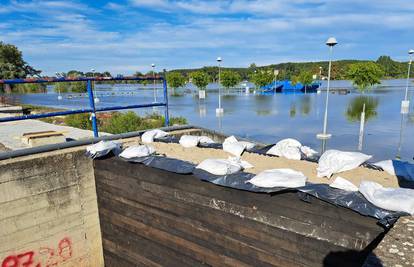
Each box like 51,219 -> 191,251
0,147 -> 103,267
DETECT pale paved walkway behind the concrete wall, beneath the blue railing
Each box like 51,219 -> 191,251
0,113 -> 108,150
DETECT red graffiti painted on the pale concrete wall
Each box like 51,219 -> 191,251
1,237 -> 72,267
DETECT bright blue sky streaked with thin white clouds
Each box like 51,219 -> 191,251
0,0 -> 414,75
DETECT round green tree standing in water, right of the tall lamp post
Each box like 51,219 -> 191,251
347,62 -> 384,92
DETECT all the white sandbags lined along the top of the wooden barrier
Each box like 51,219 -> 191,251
87,130 -> 414,217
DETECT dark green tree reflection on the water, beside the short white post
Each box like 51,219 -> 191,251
346,95 -> 379,122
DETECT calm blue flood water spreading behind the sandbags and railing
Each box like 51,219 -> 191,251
9,80 -> 414,161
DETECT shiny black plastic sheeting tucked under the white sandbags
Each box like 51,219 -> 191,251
87,136 -> 414,228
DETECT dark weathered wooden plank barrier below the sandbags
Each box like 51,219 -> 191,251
94,158 -> 383,266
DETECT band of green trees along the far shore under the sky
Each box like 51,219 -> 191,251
0,42 -> 414,94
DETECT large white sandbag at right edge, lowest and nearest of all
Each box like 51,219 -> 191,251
359,181 -> 414,215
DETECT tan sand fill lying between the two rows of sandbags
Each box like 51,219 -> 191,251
147,143 -> 398,187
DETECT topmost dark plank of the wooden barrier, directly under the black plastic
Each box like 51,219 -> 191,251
95,158 -> 382,231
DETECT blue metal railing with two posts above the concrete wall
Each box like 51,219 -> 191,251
0,73 -> 170,137
